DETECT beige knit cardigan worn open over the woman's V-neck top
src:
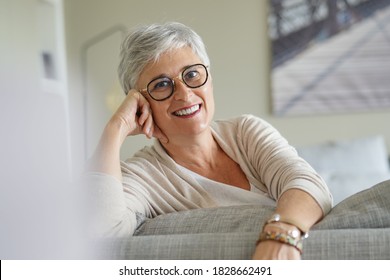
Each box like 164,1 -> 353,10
88,115 -> 332,237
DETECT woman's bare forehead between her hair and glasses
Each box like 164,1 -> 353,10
138,47 -> 201,83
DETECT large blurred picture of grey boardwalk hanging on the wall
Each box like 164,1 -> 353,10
268,0 -> 390,116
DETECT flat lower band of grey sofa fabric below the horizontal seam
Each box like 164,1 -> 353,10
102,229 -> 390,260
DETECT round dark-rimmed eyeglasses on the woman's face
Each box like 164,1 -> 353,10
140,64 -> 209,101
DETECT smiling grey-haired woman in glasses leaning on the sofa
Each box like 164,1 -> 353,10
91,23 -> 332,259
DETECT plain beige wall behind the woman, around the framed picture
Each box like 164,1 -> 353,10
65,0 -> 390,166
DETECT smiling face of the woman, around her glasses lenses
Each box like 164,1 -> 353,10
137,47 -> 215,141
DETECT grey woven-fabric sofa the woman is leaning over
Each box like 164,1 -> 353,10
100,180 -> 390,260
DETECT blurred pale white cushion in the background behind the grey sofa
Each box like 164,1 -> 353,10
297,135 -> 390,204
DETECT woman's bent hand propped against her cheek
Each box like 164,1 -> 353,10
109,89 -> 168,143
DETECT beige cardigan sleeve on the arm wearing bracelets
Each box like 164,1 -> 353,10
237,115 -> 332,214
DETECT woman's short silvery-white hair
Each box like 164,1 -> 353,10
118,22 -> 210,94
